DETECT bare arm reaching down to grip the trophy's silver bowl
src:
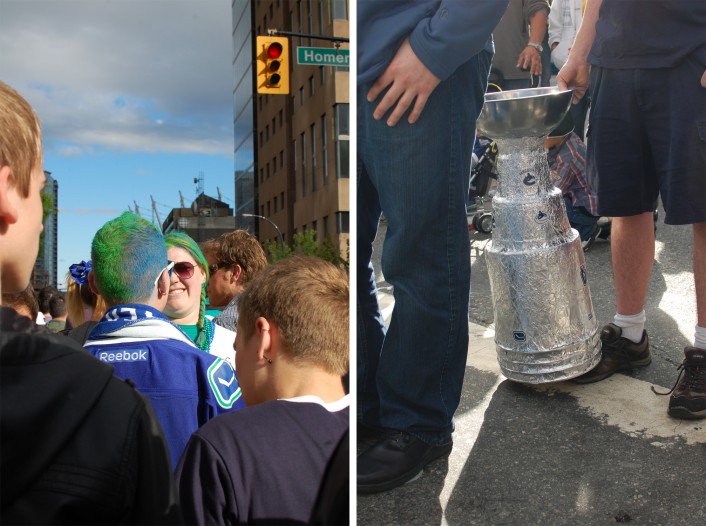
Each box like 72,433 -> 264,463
556,0 -> 603,104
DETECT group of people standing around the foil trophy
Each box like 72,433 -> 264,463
356,0 -> 706,500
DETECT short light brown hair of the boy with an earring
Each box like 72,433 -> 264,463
238,256 -> 350,376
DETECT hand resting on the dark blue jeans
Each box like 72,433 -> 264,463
367,38 -> 440,126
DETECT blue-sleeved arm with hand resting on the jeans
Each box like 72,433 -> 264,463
367,0 -> 507,126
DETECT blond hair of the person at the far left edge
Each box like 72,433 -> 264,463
0,81 -> 43,197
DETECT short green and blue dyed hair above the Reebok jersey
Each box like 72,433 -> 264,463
91,212 -> 167,306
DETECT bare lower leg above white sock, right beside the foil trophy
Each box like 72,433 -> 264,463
610,212 -> 656,319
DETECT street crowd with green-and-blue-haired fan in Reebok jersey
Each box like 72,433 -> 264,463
0,82 -> 350,525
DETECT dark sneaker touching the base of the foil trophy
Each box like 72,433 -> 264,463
571,323 -> 652,384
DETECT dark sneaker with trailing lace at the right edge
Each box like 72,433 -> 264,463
652,347 -> 706,420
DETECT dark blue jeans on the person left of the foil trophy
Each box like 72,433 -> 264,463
356,51 -> 492,445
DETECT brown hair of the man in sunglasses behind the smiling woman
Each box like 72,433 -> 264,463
212,230 -> 267,285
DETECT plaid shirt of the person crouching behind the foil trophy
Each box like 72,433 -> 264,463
547,132 -> 598,216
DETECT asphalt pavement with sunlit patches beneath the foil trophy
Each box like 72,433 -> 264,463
356,214 -> 706,525
